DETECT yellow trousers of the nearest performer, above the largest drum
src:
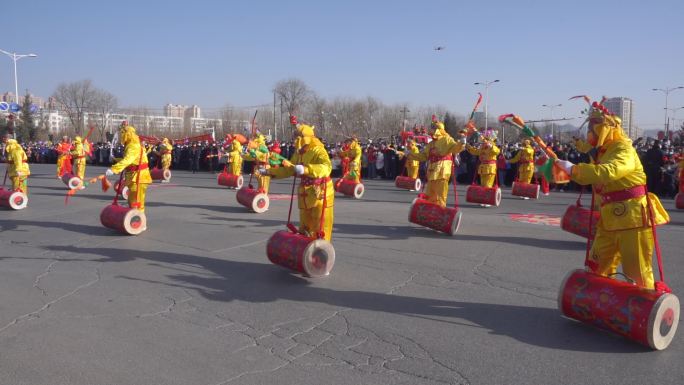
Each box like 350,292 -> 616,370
589,226 -> 653,289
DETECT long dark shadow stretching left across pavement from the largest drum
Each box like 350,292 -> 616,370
45,246 -> 647,353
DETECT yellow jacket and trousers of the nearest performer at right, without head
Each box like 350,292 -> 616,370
572,139 -> 669,289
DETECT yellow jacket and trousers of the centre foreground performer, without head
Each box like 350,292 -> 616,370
269,145 -> 335,241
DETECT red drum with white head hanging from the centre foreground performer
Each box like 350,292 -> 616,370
266,230 -> 335,278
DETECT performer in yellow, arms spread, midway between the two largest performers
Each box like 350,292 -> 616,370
406,121 -> 464,207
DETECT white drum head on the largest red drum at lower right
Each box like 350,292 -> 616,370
647,293 -> 679,350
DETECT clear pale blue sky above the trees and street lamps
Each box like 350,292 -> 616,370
0,0 -> 684,129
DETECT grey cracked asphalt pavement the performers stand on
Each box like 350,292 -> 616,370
0,165 -> 684,385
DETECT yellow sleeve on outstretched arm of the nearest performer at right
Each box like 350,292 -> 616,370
572,143 -> 638,184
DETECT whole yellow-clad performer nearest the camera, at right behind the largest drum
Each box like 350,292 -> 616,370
556,103 -> 669,289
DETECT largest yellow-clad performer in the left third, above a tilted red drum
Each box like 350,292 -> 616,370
106,125 -> 152,212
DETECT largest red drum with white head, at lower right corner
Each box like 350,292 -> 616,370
558,269 -> 679,350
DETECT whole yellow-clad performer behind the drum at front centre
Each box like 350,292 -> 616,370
267,119 -> 335,241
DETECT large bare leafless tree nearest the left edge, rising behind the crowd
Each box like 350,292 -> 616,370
52,79 -> 98,135
